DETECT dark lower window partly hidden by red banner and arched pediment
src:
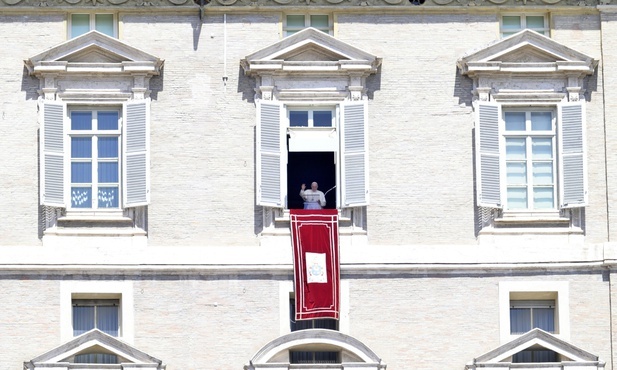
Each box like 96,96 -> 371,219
289,298 -> 341,364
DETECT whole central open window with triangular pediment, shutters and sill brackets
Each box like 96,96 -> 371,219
241,27 -> 381,234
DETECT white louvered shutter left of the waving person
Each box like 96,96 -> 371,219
256,100 -> 286,208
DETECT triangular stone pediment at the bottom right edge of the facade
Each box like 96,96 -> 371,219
467,328 -> 604,369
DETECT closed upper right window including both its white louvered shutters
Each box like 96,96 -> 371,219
476,102 -> 587,216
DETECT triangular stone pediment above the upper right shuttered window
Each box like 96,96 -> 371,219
457,30 -> 598,75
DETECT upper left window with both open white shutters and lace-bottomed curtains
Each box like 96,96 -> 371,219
41,100 -> 149,212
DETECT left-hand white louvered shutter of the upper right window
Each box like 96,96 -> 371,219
475,102 -> 502,208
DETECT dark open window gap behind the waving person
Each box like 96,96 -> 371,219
287,152 -> 337,209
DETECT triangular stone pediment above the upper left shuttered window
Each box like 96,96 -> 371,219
25,31 -> 163,75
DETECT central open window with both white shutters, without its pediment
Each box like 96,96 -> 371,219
257,101 -> 368,209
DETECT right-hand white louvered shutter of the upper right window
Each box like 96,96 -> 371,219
558,102 -> 587,208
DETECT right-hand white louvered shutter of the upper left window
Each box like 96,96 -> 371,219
122,99 -> 150,207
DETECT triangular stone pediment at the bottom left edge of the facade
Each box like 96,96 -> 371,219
24,329 -> 165,370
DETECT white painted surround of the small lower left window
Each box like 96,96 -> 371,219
60,281 -> 135,344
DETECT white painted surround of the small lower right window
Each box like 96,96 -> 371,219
499,281 -> 570,344
